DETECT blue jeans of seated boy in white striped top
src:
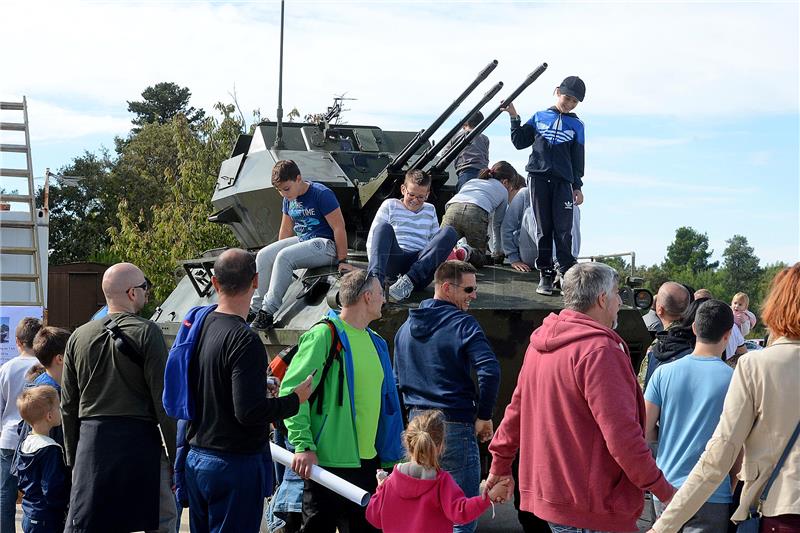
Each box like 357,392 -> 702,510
369,222 -> 458,289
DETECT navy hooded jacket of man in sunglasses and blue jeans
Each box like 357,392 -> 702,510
394,299 -> 500,422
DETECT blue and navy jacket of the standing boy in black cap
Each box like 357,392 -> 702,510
511,107 -> 585,189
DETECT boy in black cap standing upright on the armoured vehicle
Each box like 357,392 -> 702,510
504,76 -> 586,295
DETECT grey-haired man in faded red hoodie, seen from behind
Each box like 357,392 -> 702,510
488,263 -> 675,533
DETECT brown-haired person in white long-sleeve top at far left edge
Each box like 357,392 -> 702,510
0,317 -> 42,533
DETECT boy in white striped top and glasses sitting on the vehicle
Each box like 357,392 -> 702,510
367,170 -> 458,301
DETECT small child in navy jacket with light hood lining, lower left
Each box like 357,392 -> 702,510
17,385 -> 70,533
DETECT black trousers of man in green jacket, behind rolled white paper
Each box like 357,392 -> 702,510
301,457 -> 381,533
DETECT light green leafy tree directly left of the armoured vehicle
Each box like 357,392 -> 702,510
111,104 -> 243,301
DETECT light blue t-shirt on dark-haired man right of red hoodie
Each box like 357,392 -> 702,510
644,354 -> 733,503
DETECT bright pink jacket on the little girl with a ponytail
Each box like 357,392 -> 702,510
367,468 -> 491,533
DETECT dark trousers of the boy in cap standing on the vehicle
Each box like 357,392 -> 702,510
528,176 -> 576,274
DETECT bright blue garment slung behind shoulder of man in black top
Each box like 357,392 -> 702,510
161,304 -> 217,420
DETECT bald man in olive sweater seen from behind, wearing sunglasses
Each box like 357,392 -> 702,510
61,263 -> 177,533
